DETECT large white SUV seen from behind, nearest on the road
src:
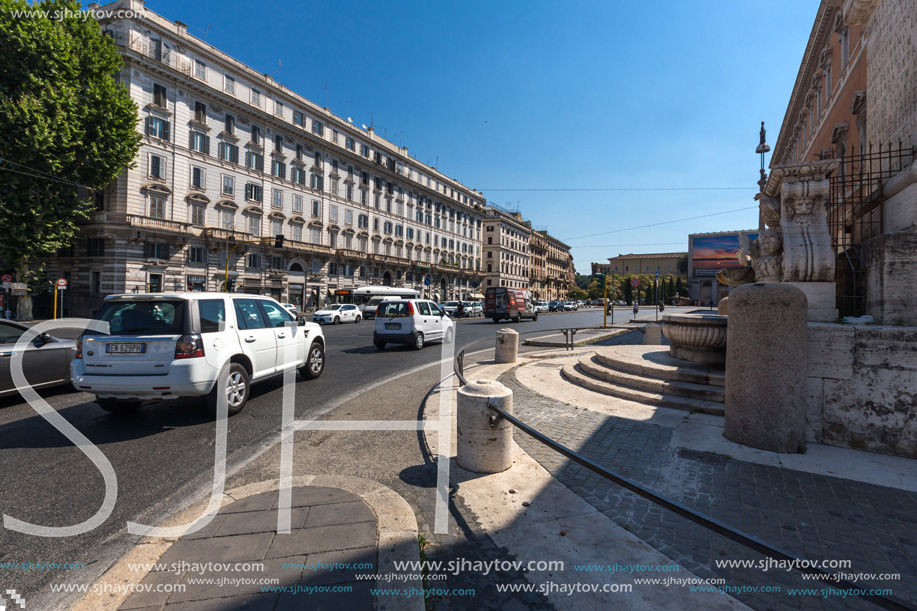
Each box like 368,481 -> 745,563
70,293 -> 325,415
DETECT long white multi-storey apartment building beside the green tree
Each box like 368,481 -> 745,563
47,0 -> 486,315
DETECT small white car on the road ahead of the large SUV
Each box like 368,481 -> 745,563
373,299 -> 455,350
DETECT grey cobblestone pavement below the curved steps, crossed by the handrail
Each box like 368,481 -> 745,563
500,334 -> 917,609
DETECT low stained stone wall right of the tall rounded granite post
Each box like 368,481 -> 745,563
806,323 -> 917,458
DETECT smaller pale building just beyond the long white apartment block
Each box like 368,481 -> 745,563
481,205 -> 532,289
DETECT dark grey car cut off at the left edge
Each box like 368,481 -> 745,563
0,319 -> 76,397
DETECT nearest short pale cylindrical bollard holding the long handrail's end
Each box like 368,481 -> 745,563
455,380 -> 513,473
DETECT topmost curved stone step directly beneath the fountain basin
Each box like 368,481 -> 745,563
595,346 -> 726,388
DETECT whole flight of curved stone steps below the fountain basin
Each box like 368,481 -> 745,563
563,346 -> 726,416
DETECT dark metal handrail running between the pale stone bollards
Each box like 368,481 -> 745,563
453,327 -> 917,611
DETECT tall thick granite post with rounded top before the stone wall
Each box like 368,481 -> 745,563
723,283 -> 807,452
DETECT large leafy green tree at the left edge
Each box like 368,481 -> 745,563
0,0 -> 141,318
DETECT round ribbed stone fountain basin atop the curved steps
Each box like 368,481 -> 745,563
662,314 -> 727,365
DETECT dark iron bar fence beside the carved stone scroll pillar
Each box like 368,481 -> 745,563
827,141 -> 915,316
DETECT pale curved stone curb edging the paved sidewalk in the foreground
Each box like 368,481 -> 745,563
72,475 -> 424,611
